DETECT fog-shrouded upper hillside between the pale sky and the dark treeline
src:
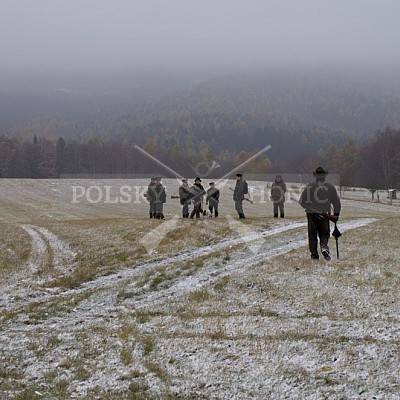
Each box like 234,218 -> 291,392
0,69 -> 400,145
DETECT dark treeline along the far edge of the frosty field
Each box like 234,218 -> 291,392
0,127 -> 400,189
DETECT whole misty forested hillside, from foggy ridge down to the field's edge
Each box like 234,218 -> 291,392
0,70 -> 400,187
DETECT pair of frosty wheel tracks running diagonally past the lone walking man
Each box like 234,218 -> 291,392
2,218 -> 377,321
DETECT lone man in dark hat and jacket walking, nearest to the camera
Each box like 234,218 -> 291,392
299,167 -> 341,260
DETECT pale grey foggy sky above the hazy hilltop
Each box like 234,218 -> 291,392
0,0 -> 400,74
